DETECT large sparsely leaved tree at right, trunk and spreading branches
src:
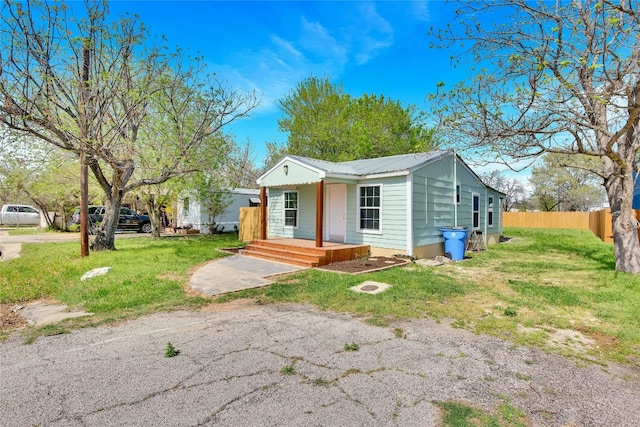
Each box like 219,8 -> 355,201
431,0 -> 640,273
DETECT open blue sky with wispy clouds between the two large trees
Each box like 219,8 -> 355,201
110,1 -> 459,163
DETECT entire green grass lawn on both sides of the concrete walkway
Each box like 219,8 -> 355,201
0,229 -> 640,362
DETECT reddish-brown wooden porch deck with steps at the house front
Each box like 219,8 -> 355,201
241,239 -> 370,267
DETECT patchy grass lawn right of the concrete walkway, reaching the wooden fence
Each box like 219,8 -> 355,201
218,229 -> 640,362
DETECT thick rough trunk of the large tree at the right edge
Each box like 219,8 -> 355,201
605,163 -> 640,274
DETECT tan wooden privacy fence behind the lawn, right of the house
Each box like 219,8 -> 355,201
502,209 -> 640,243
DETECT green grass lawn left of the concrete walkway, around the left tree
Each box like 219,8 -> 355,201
0,234 -> 241,338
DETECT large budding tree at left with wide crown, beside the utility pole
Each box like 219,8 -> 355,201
0,0 -> 258,249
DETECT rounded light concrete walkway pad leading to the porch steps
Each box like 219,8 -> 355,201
190,255 -> 304,296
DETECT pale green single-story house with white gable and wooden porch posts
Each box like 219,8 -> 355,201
257,150 -> 505,258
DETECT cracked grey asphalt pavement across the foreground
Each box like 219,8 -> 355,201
0,303 -> 640,426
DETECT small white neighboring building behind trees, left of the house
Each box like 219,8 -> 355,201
177,188 -> 260,233
